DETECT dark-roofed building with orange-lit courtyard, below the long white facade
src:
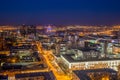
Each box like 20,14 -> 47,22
72,68 -> 117,80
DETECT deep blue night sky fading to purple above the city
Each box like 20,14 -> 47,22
0,0 -> 120,25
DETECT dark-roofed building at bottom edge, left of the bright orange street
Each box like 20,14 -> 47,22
0,72 -> 56,80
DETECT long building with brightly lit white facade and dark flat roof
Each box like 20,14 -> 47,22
61,54 -> 120,70
